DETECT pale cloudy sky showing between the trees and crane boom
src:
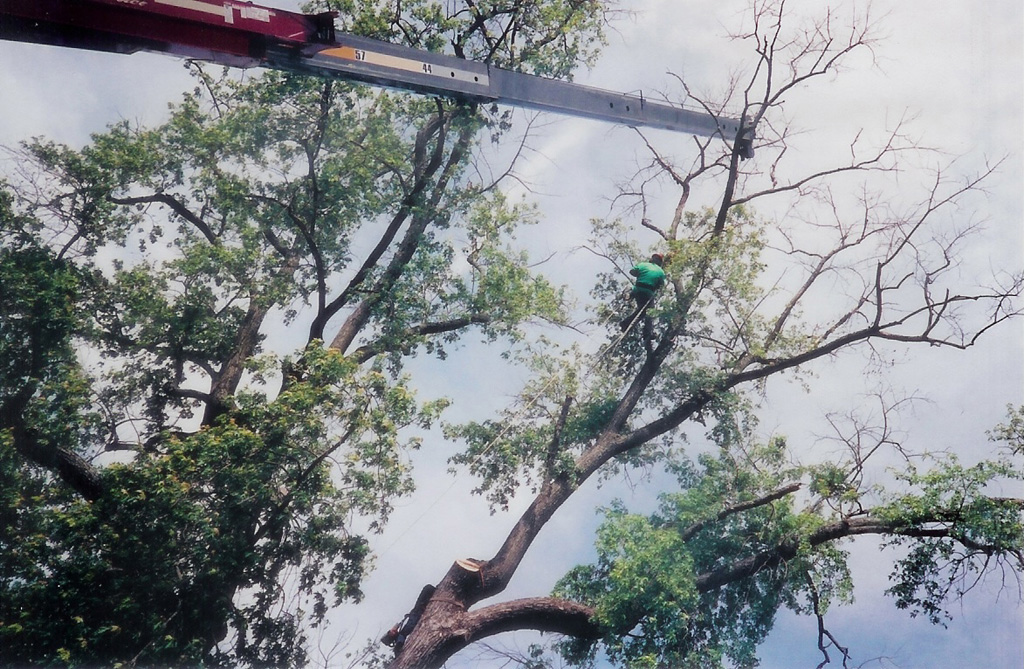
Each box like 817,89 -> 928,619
0,0 -> 1024,669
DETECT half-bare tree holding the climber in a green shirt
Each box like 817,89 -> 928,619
370,2 -> 1024,669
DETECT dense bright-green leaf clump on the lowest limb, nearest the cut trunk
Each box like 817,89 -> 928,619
556,432 -> 827,667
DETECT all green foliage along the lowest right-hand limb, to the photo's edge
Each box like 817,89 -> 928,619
555,409 -> 1024,667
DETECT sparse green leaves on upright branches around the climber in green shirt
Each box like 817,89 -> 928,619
447,208 -> 782,507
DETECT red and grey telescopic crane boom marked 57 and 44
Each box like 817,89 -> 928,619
0,0 -> 753,146
